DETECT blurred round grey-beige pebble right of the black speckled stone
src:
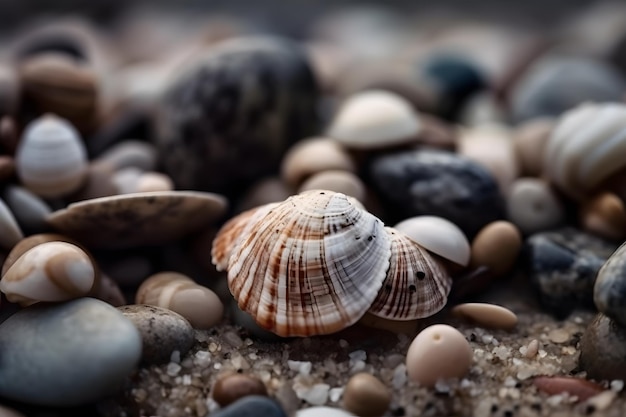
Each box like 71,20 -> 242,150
507,178 -> 565,234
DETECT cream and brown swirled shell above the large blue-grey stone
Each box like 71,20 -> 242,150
0,242 -> 96,306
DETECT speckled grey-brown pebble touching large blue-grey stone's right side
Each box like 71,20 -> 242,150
118,304 -> 194,364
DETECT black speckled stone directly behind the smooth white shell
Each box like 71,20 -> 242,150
369,149 -> 504,239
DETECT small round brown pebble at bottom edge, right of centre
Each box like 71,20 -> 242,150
343,372 -> 391,417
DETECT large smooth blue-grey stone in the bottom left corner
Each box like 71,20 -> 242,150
0,298 -> 141,406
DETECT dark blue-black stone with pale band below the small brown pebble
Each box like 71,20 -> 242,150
523,228 -> 616,318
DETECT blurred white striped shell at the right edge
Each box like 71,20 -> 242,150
543,103 -> 626,198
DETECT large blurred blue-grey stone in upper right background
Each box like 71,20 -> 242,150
511,56 -> 626,123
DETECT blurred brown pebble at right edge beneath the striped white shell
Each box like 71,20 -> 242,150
580,193 -> 626,241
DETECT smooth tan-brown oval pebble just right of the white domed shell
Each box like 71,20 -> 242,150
470,220 -> 522,277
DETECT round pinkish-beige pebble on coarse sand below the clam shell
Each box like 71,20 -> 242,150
406,324 -> 473,387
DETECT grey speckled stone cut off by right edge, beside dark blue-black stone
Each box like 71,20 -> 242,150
593,243 -> 626,326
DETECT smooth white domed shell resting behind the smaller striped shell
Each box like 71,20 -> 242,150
394,216 -> 471,266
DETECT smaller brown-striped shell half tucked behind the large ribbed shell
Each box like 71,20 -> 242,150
368,227 -> 452,320
